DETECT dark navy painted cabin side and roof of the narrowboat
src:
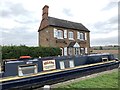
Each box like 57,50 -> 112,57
3,54 -> 115,77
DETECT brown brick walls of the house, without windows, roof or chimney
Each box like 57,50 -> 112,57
39,26 -> 90,52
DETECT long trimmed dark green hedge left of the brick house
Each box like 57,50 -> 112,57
2,45 -> 61,59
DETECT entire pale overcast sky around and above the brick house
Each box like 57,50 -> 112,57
0,0 -> 119,46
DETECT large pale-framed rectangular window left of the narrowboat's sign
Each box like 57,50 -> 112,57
18,65 -> 37,76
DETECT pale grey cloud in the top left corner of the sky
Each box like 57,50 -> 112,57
0,2 -> 30,18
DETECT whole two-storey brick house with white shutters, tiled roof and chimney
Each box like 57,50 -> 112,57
38,5 -> 90,55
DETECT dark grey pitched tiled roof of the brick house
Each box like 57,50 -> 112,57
48,17 -> 89,32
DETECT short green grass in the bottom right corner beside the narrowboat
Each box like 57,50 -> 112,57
53,71 -> 118,90
